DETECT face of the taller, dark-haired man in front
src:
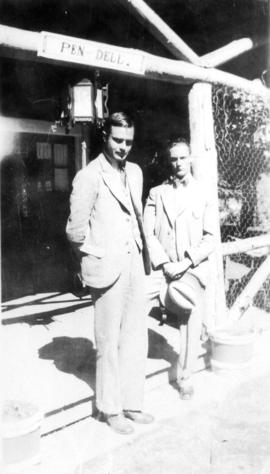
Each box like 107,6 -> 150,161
105,125 -> 134,163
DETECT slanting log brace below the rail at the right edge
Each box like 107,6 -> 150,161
229,255 -> 270,321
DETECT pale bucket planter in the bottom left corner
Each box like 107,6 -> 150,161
2,400 -> 42,474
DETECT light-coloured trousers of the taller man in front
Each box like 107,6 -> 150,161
92,243 -> 148,414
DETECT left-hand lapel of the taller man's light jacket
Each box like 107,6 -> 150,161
98,153 -> 130,212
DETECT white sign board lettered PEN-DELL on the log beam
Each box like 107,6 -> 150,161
38,31 -> 146,75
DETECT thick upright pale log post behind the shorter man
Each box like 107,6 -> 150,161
189,83 -> 227,327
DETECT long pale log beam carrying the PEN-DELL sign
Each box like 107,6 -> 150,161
0,25 -> 270,98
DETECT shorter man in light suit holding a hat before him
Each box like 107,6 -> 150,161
144,138 -> 214,399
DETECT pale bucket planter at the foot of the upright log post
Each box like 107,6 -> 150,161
210,323 -> 255,374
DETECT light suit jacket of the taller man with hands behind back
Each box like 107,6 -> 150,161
66,154 -> 150,288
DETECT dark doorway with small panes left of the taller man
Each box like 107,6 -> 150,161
1,133 -> 74,300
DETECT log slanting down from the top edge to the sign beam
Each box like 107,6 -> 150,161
119,0 -> 201,65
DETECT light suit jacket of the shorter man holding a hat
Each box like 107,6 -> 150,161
144,175 -> 215,285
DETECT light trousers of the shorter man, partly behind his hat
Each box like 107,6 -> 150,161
145,270 -> 205,381
